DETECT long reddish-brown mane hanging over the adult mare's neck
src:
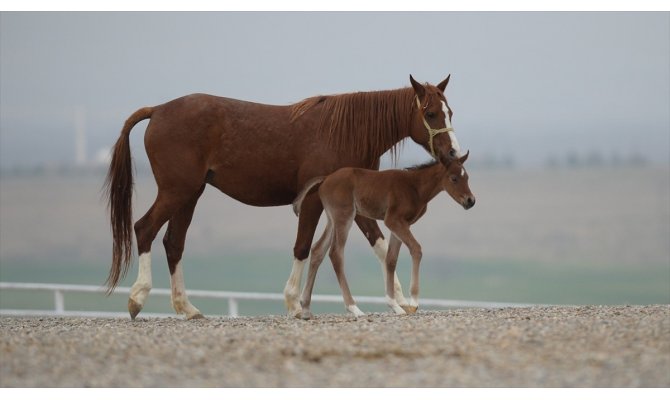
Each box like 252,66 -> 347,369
291,87 -> 414,160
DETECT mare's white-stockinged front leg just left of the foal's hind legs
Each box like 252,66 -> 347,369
284,193 -> 323,318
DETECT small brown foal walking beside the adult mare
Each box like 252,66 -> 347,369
293,152 -> 475,319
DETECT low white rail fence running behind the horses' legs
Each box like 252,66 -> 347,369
0,282 -> 537,317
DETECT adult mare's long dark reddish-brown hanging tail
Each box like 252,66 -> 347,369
104,107 -> 153,294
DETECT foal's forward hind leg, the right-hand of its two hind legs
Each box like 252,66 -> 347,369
328,209 -> 365,317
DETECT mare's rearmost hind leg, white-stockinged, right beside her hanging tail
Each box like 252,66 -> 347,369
128,188 -> 202,319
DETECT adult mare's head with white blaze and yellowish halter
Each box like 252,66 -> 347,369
409,75 -> 461,166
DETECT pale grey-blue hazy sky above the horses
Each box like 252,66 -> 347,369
0,12 -> 670,167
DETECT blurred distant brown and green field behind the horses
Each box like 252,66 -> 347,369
0,168 -> 670,315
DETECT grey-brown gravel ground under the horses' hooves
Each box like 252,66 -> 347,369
0,305 -> 670,387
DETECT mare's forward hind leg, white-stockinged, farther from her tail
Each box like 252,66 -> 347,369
163,184 -> 205,319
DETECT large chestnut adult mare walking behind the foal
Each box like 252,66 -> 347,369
105,75 -> 458,319
